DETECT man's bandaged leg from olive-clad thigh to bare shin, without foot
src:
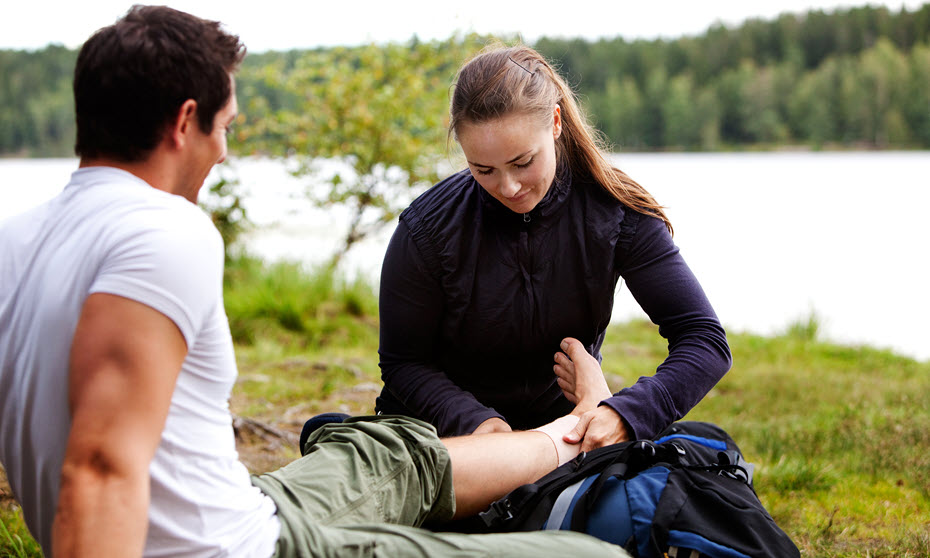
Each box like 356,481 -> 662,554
253,416 -> 578,526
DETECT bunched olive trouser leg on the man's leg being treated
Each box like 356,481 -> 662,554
252,416 -> 455,531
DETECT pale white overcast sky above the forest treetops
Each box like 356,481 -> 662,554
0,0 -> 923,52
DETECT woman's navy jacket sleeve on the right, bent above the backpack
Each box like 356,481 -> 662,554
601,211 -> 732,439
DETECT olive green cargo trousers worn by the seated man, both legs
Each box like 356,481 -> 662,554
252,416 -> 628,558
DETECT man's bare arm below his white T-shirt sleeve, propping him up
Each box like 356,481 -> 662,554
52,293 -> 187,558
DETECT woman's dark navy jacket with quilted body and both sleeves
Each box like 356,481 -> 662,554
377,170 -> 730,438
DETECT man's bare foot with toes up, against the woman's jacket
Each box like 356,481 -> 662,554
552,337 -> 612,416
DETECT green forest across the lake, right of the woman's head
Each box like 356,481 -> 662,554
535,4 -> 930,150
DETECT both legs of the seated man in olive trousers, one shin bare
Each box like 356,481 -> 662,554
253,376 -> 625,556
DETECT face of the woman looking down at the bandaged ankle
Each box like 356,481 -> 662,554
457,106 -> 562,213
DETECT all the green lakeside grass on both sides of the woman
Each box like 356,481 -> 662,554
0,259 -> 930,558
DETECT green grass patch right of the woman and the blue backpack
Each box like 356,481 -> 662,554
687,324 -> 930,557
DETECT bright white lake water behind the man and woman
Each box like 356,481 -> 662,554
0,151 -> 930,360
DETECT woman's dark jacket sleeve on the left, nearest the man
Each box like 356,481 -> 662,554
378,221 -> 504,436
